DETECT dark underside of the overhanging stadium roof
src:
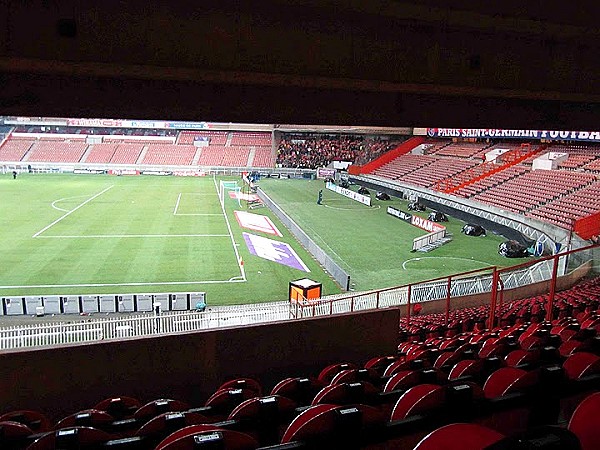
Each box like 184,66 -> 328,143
0,0 -> 600,129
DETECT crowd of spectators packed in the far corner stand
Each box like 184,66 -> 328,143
277,135 -> 399,169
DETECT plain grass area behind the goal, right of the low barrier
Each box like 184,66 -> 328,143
260,179 -> 521,290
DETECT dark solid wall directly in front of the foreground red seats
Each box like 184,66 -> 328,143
0,309 -> 399,419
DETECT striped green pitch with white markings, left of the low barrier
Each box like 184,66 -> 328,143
0,174 -> 339,304
